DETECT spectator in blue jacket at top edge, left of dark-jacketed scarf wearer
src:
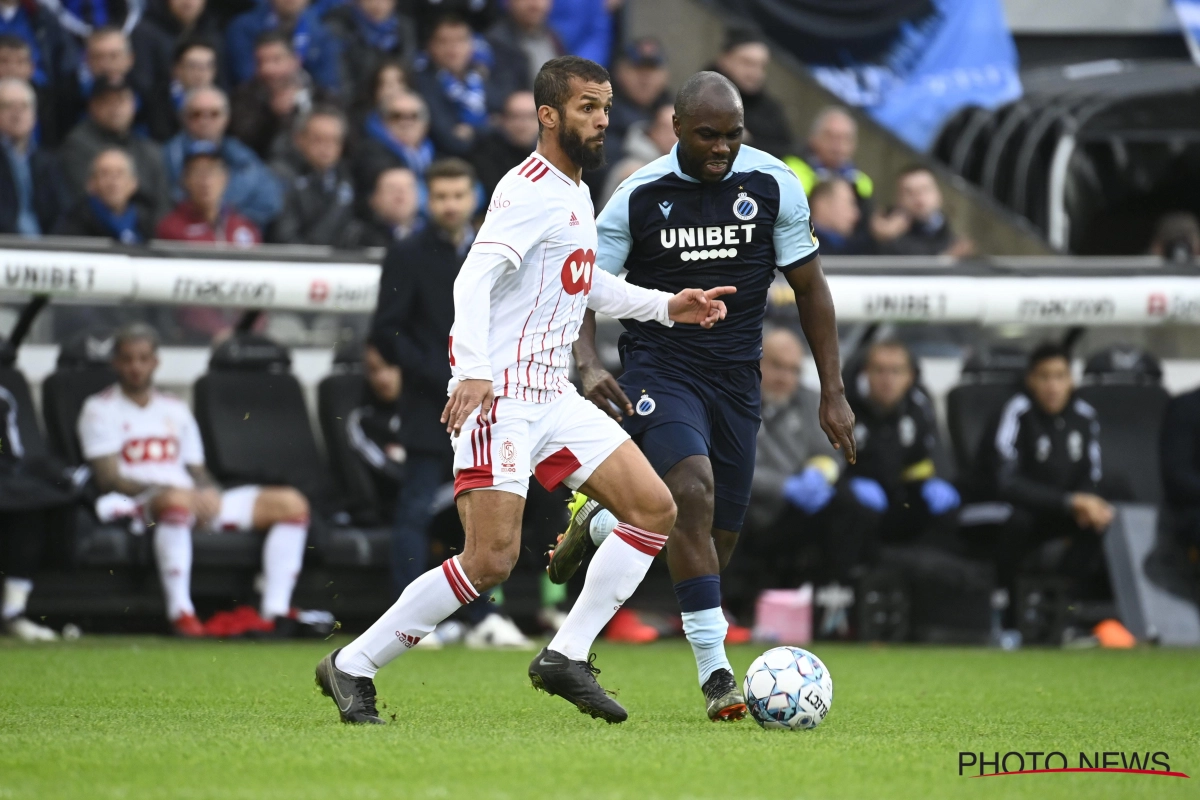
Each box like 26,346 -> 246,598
226,0 -> 342,92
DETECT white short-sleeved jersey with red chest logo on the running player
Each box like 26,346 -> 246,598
450,152 -> 596,403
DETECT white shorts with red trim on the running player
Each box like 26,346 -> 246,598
451,390 -> 629,497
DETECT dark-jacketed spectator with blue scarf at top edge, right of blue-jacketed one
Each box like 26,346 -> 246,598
325,0 -> 416,95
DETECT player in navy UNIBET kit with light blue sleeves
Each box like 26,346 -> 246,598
550,72 -> 854,720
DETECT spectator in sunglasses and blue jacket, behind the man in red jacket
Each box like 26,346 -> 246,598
163,86 -> 283,229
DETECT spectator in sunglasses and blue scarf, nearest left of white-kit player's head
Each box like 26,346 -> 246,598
353,91 -> 433,215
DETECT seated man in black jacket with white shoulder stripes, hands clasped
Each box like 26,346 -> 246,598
979,344 -> 1112,595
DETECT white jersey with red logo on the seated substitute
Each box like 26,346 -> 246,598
79,384 -> 204,489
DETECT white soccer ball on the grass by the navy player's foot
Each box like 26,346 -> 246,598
742,648 -> 833,730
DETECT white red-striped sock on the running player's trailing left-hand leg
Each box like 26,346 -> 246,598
335,555 -> 479,678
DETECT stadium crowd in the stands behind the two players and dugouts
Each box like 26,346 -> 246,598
0,0 -> 988,255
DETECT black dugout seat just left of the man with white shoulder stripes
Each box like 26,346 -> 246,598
946,348 -> 1026,477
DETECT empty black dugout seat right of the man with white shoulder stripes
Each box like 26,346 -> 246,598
1079,347 -> 1171,504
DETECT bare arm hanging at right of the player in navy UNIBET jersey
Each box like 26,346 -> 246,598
784,257 -> 857,464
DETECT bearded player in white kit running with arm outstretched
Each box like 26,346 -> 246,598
317,56 -> 734,724
